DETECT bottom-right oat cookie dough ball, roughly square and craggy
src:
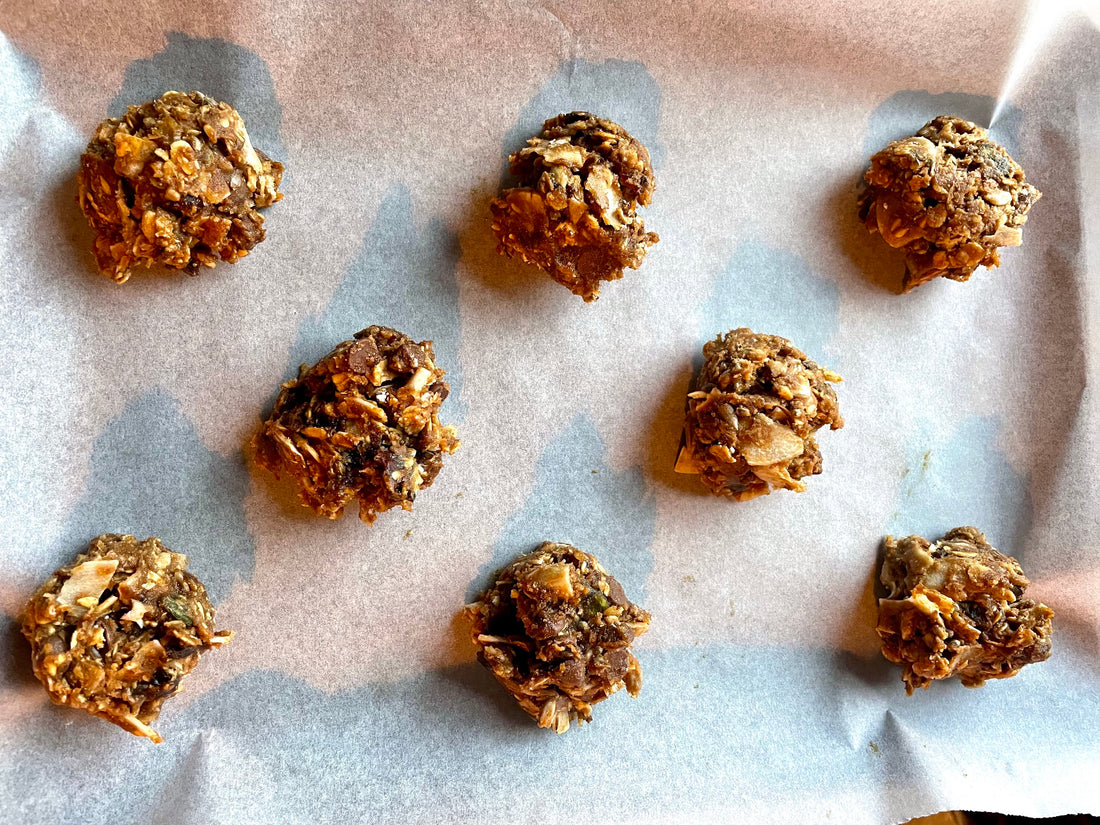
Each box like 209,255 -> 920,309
876,527 -> 1054,694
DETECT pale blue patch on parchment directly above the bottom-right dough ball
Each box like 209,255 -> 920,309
887,416 -> 1032,563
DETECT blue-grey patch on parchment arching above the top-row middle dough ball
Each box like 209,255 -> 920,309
501,58 -> 664,180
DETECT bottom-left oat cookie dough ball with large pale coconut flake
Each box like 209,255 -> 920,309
23,534 -> 233,741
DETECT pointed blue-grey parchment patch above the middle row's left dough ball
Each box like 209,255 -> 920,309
287,184 -> 465,420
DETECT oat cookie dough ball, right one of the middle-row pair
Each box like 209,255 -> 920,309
677,327 -> 844,502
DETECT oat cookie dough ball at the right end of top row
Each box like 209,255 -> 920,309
859,118 -> 1040,292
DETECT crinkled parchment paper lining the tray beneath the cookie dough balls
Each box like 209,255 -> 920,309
0,0 -> 1100,825
